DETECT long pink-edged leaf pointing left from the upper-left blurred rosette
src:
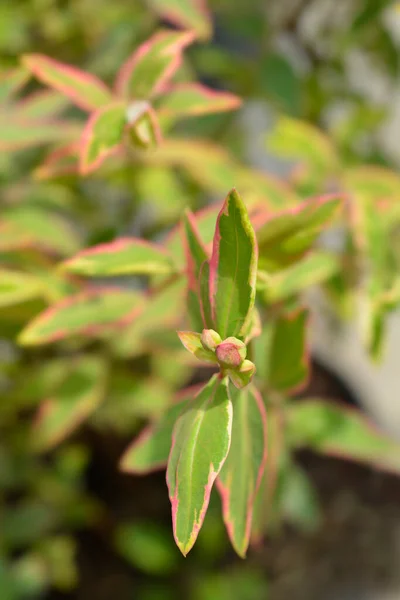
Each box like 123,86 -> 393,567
22,54 -> 112,112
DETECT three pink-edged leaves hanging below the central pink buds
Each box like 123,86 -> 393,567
121,376 -> 266,556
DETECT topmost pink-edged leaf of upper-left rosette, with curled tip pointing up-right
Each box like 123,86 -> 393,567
115,30 -> 194,100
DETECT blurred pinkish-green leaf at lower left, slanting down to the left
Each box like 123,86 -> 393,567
32,356 -> 105,450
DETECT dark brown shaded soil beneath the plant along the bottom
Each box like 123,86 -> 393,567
47,361 -> 400,600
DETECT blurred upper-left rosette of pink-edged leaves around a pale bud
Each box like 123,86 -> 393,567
23,30 -> 240,174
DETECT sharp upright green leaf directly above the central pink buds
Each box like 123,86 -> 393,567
209,190 -> 257,339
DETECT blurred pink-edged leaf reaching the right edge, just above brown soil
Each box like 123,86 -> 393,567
287,398 -> 400,474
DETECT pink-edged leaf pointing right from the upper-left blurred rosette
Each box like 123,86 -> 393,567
159,83 -> 241,117
